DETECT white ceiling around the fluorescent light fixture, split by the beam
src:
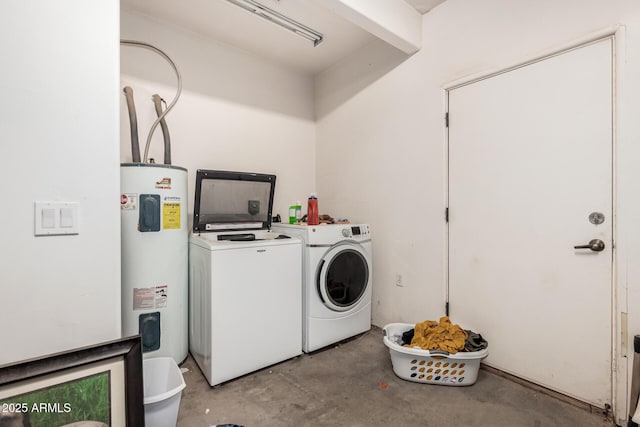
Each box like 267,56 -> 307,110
121,0 -> 444,75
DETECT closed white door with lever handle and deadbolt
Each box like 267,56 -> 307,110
448,38 -> 613,407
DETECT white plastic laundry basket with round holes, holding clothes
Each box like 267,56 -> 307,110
382,323 -> 489,386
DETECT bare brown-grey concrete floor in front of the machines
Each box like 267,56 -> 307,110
178,327 -> 613,427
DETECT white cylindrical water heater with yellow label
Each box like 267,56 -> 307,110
120,163 -> 189,364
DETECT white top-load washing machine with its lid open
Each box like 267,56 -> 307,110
189,170 -> 302,386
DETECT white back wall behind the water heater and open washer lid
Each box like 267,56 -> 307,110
120,11 -> 316,219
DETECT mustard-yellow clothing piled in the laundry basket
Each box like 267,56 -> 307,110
407,316 -> 467,353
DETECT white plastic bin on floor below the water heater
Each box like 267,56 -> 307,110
142,357 -> 185,427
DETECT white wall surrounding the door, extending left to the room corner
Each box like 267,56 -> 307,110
316,0 -> 640,422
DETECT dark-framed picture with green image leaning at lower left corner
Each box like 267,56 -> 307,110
0,335 -> 144,427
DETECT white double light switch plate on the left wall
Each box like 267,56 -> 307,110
34,202 -> 80,236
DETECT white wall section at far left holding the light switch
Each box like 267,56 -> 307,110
0,0 -> 120,364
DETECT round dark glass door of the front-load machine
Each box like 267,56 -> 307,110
316,243 -> 370,311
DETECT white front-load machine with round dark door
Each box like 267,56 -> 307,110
272,223 -> 373,353
